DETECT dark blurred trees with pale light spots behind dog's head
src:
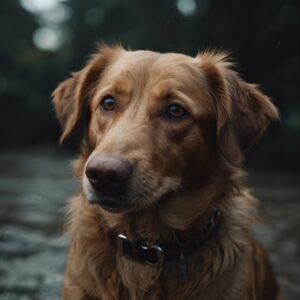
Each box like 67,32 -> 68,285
0,0 -> 300,170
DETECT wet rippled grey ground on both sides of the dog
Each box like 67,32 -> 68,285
0,151 -> 300,300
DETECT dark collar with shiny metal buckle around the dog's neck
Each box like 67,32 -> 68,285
109,210 -> 221,278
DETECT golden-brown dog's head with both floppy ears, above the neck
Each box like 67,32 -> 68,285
53,47 -> 278,212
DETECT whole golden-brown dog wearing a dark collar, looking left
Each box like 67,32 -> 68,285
54,47 -> 282,300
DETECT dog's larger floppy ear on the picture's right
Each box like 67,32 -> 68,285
199,53 -> 279,164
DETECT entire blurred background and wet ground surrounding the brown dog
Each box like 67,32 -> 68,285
0,0 -> 300,300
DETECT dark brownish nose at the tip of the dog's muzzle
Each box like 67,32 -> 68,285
85,155 -> 133,194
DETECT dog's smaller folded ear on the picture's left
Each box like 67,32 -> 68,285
52,46 -> 121,143
